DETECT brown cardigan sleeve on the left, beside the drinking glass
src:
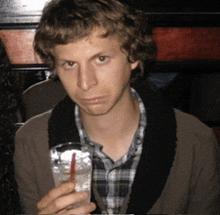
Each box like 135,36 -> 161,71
14,112 -> 55,214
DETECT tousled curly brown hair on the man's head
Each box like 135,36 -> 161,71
34,0 -> 156,79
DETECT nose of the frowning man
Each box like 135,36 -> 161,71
77,65 -> 98,91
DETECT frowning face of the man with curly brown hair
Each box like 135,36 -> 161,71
54,29 -> 138,116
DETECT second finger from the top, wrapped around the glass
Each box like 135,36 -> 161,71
39,192 -> 89,214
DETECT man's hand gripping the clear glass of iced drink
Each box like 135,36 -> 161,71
37,182 -> 96,214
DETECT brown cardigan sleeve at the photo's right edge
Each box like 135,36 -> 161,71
188,124 -> 220,214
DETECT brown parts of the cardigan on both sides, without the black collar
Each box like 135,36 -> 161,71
14,110 -> 220,214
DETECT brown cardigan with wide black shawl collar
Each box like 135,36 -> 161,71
14,82 -> 220,214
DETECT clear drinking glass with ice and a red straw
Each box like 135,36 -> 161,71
50,142 -> 92,207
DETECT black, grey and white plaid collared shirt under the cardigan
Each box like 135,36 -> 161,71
75,88 -> 146,214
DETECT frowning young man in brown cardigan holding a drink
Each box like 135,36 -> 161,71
14,0 -> 220,214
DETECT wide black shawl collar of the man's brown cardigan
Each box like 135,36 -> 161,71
48,81 -> 177,214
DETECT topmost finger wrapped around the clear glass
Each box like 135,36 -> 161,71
37,182 -> 75,211
